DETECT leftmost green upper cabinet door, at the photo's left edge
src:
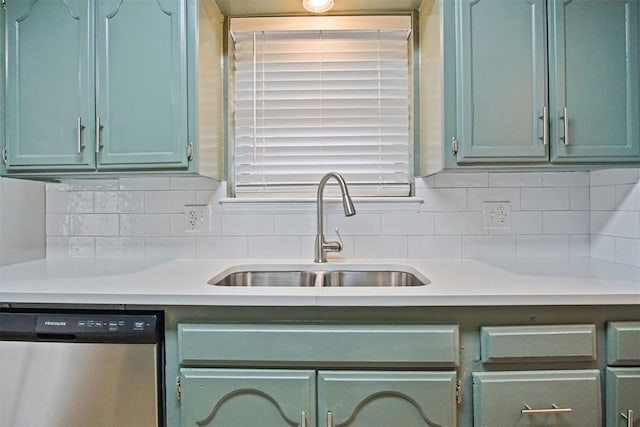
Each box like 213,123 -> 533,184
6,0 -> 95,172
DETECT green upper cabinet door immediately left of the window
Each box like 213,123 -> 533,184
95,0 -> 188,170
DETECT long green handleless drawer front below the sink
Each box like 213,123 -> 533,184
178,324 -> 459,367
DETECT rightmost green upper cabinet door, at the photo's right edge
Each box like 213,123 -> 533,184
549,0 -> 640,163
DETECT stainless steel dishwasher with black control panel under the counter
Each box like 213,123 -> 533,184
0,310 -> 164,427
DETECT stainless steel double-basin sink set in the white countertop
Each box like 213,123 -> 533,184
207,264 -> 430,287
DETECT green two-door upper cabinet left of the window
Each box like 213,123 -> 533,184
5,0 -> 189,175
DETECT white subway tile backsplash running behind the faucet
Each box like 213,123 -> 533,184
41,168 -> 640,265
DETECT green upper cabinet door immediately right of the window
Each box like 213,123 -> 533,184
456,0 -> 548,164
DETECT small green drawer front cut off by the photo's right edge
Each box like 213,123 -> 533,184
607,322 -> 640,366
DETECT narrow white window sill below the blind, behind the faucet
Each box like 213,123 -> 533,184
219,197 -> 424,213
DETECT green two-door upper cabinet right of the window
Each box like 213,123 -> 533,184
453,0 -> 640,165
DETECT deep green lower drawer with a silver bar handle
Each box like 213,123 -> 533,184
473,370 -> 602,427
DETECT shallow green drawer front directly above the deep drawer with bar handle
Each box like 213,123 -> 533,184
480,325 -> 596,363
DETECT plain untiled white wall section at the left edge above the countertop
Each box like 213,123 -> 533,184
0,178 -> 45,265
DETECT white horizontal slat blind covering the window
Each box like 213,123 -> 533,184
231,17 -> 412,197
